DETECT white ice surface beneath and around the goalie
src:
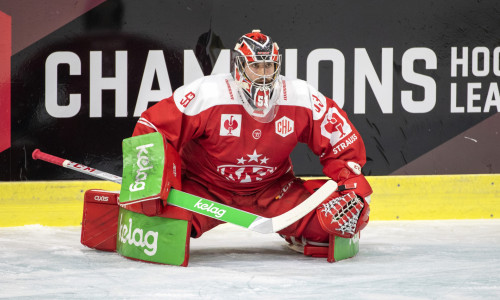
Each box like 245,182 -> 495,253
0,219 -> 500,300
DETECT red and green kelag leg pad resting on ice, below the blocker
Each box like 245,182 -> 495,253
81,190 -> 192,266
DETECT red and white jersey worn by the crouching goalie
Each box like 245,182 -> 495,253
134,74 -> 366,193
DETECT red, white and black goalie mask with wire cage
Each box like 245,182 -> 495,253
233,30 -> 281,123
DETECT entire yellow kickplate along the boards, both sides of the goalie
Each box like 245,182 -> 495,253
0,174 -> 500,227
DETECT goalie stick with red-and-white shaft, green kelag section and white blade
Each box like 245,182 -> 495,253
32,149 -> 337,233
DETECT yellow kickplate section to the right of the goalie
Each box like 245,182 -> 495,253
368,174 -> 500,220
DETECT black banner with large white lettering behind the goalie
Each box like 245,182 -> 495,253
0,0 -> 500,181
